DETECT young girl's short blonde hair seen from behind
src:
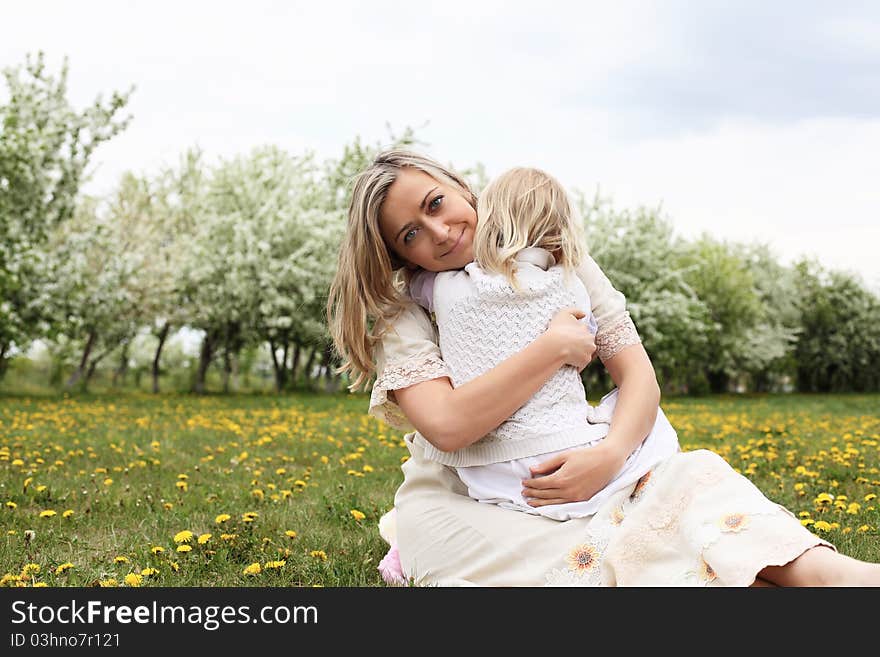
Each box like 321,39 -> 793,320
474,167 -> 584,289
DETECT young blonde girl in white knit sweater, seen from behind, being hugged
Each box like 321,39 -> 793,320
409,168 -> 678,520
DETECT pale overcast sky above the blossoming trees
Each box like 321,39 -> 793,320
0,0 -> 880,289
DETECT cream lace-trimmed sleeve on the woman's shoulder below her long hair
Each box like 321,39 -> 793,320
369,303 -> 449,431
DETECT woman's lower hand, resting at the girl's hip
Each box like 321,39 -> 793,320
522,438 -> 628,507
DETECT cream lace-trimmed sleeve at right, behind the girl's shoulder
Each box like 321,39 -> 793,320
577,256 -> 642,363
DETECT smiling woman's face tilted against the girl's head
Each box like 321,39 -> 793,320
379,168 -> 477,271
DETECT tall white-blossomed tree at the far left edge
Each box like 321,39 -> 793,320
0,53 -> 131,376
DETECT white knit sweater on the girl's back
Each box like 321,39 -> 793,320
410,249 -> 607,467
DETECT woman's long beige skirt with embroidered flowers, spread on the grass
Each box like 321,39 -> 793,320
395,434 -> 834,586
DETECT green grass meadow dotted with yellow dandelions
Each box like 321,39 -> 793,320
0,393 -> 880,586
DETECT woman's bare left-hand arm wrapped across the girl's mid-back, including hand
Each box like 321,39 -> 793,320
394,308 -> 595,452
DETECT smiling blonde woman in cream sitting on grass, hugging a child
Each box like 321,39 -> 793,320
328,151 -> 880,586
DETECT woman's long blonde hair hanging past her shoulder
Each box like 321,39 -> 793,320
327,150 -> 476,391
